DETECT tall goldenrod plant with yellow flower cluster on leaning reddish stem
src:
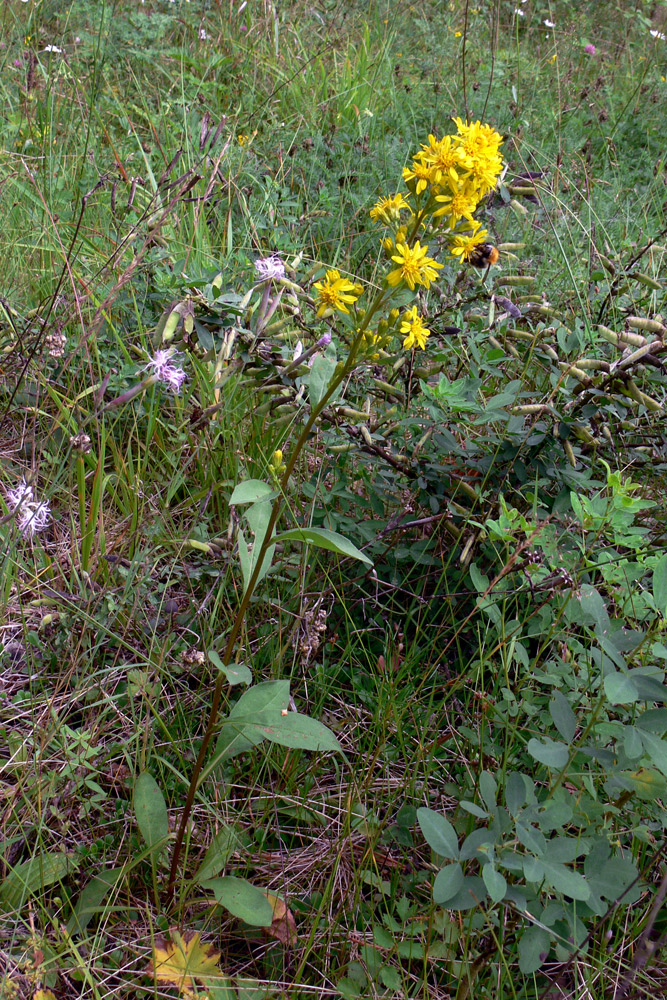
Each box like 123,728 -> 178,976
166,118 -> 503,901
